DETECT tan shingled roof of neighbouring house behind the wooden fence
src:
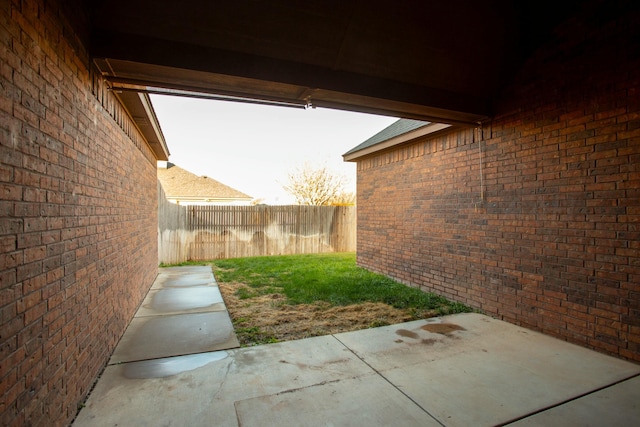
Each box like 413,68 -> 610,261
158,162 -> 253,200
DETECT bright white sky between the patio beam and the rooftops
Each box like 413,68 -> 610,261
151,95 -> 397,204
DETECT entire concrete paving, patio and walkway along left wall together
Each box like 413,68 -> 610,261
74,267 -> 640,427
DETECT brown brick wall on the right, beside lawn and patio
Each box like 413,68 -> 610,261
358,5 -> 640,361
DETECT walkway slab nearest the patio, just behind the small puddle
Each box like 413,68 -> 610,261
109,311 -> 240,365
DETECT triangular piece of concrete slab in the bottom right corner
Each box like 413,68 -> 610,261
510,377 -> 640,427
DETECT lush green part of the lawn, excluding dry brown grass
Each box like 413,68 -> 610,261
207,253 -> 472,318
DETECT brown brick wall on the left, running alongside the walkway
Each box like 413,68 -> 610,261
0,0 -> 157,426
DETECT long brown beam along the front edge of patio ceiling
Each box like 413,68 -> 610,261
95,58 -> 489,125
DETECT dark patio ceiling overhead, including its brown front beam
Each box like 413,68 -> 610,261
86,0 -> 576,123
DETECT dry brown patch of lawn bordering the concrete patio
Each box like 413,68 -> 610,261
218,282 -> 436,346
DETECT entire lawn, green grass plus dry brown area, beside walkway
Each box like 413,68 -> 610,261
211,254 -> 470,346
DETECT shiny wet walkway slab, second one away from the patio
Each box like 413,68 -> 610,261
136,285 -> 227,317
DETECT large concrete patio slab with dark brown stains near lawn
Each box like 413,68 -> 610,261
336,313 -> 640,426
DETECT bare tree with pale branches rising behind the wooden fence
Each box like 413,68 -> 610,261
282,164 -> 353,206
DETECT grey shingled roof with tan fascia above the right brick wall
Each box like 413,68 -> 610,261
342,119 -> 451,161
